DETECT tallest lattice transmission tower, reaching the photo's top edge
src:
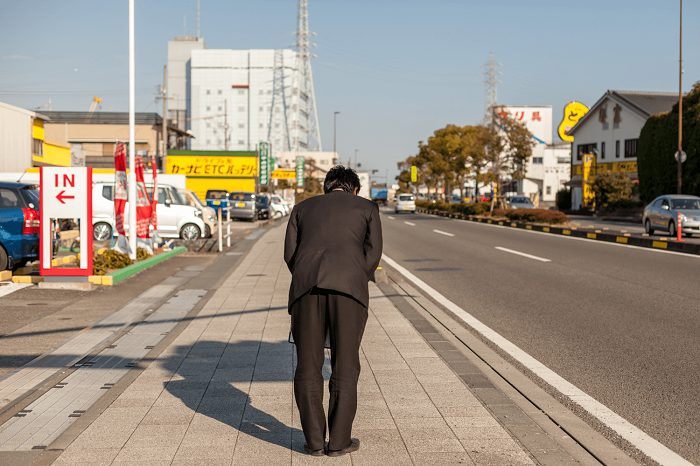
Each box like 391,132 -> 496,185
291,0 -> 323,152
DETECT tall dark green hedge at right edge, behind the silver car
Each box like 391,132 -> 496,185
637,81 -> 700,202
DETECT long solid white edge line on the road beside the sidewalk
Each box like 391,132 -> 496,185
382,254 -> 692,466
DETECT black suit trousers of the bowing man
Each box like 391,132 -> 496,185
291,287 -> 367,450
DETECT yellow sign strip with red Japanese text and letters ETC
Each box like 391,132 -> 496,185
165,154 -> 258,178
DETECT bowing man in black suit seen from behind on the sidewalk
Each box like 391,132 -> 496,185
284,166 -> 382,456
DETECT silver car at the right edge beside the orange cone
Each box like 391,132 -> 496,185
642,194 -> 700,236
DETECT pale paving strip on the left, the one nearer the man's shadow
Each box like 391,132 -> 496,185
0,290 -> 206,451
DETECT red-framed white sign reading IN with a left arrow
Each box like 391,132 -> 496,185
39,167 -> 92,276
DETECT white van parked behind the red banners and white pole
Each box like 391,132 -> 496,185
92,182 -> 205,241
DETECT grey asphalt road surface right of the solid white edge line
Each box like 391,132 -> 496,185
382,208 -> 700,464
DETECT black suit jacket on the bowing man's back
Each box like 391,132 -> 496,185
284,191 -> 382,307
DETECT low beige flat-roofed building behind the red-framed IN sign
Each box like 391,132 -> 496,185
44,112 -> 190,168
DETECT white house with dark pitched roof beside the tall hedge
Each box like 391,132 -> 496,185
568,90 -> 678,210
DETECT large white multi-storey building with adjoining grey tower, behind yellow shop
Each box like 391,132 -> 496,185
168,44 -> 312,158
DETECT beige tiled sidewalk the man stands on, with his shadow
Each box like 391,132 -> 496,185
53,227 -> 534,466
